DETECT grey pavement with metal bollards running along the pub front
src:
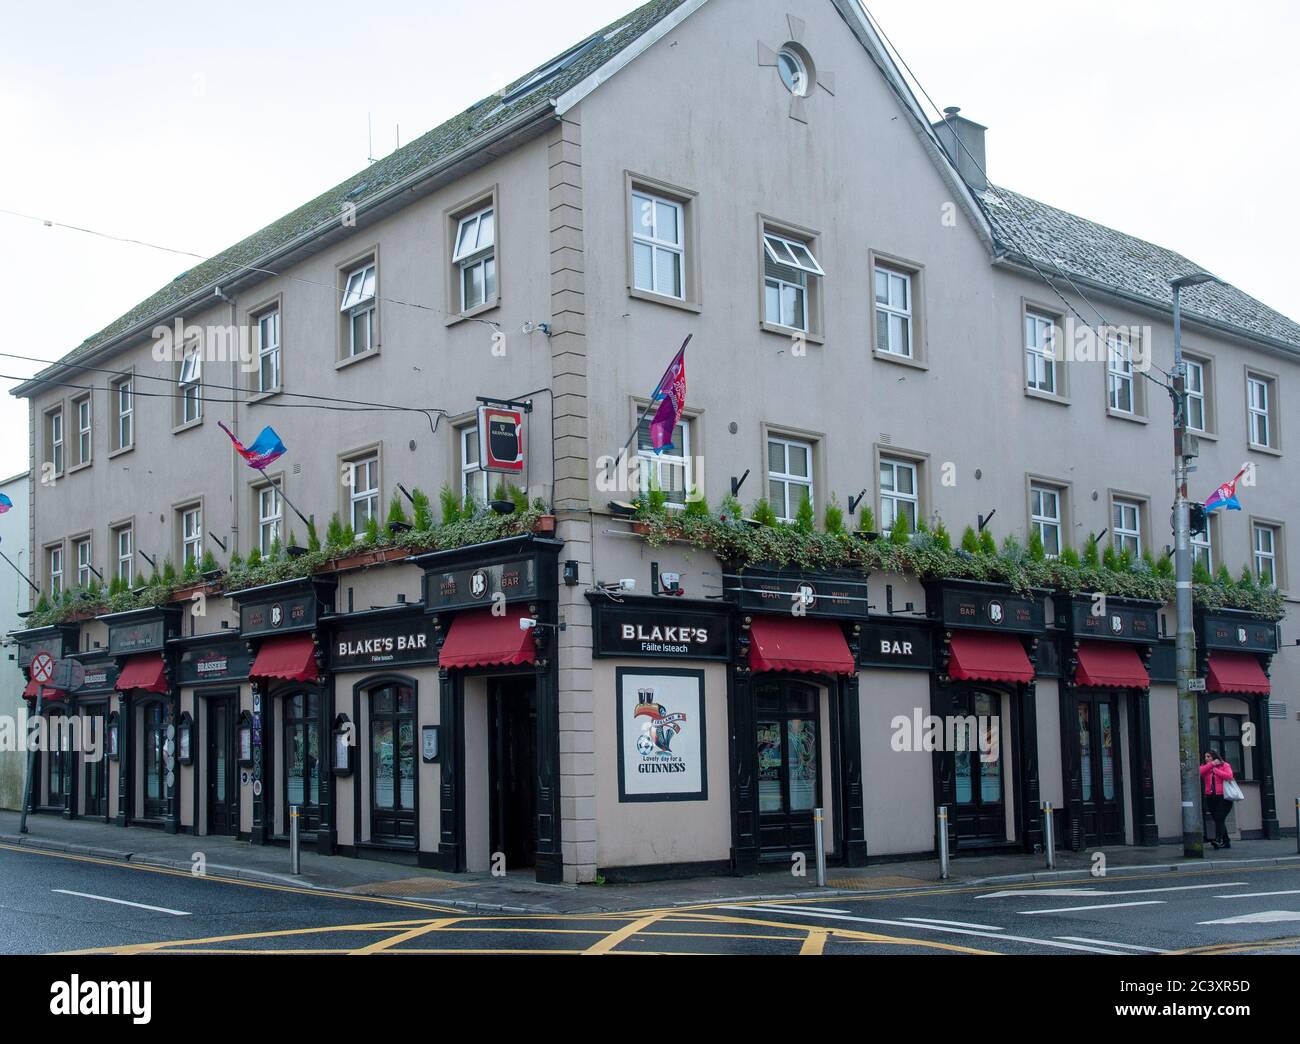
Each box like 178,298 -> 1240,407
0,810 -> 1300,913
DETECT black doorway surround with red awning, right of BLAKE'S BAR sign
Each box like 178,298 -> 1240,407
412,536 -> 564,883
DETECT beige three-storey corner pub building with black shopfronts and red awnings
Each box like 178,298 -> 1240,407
14,0 -> 1300,881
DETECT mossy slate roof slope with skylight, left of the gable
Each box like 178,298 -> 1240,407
20,0 -> 685,381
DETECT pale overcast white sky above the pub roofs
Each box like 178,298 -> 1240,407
0,0 -> 1300,477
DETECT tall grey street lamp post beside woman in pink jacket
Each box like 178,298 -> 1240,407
1169,272 -> 1217,859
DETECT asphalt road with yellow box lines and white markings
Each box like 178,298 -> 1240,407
0,845 -> 1300,956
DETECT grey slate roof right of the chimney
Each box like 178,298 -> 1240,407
982,185 -> 1300,350
